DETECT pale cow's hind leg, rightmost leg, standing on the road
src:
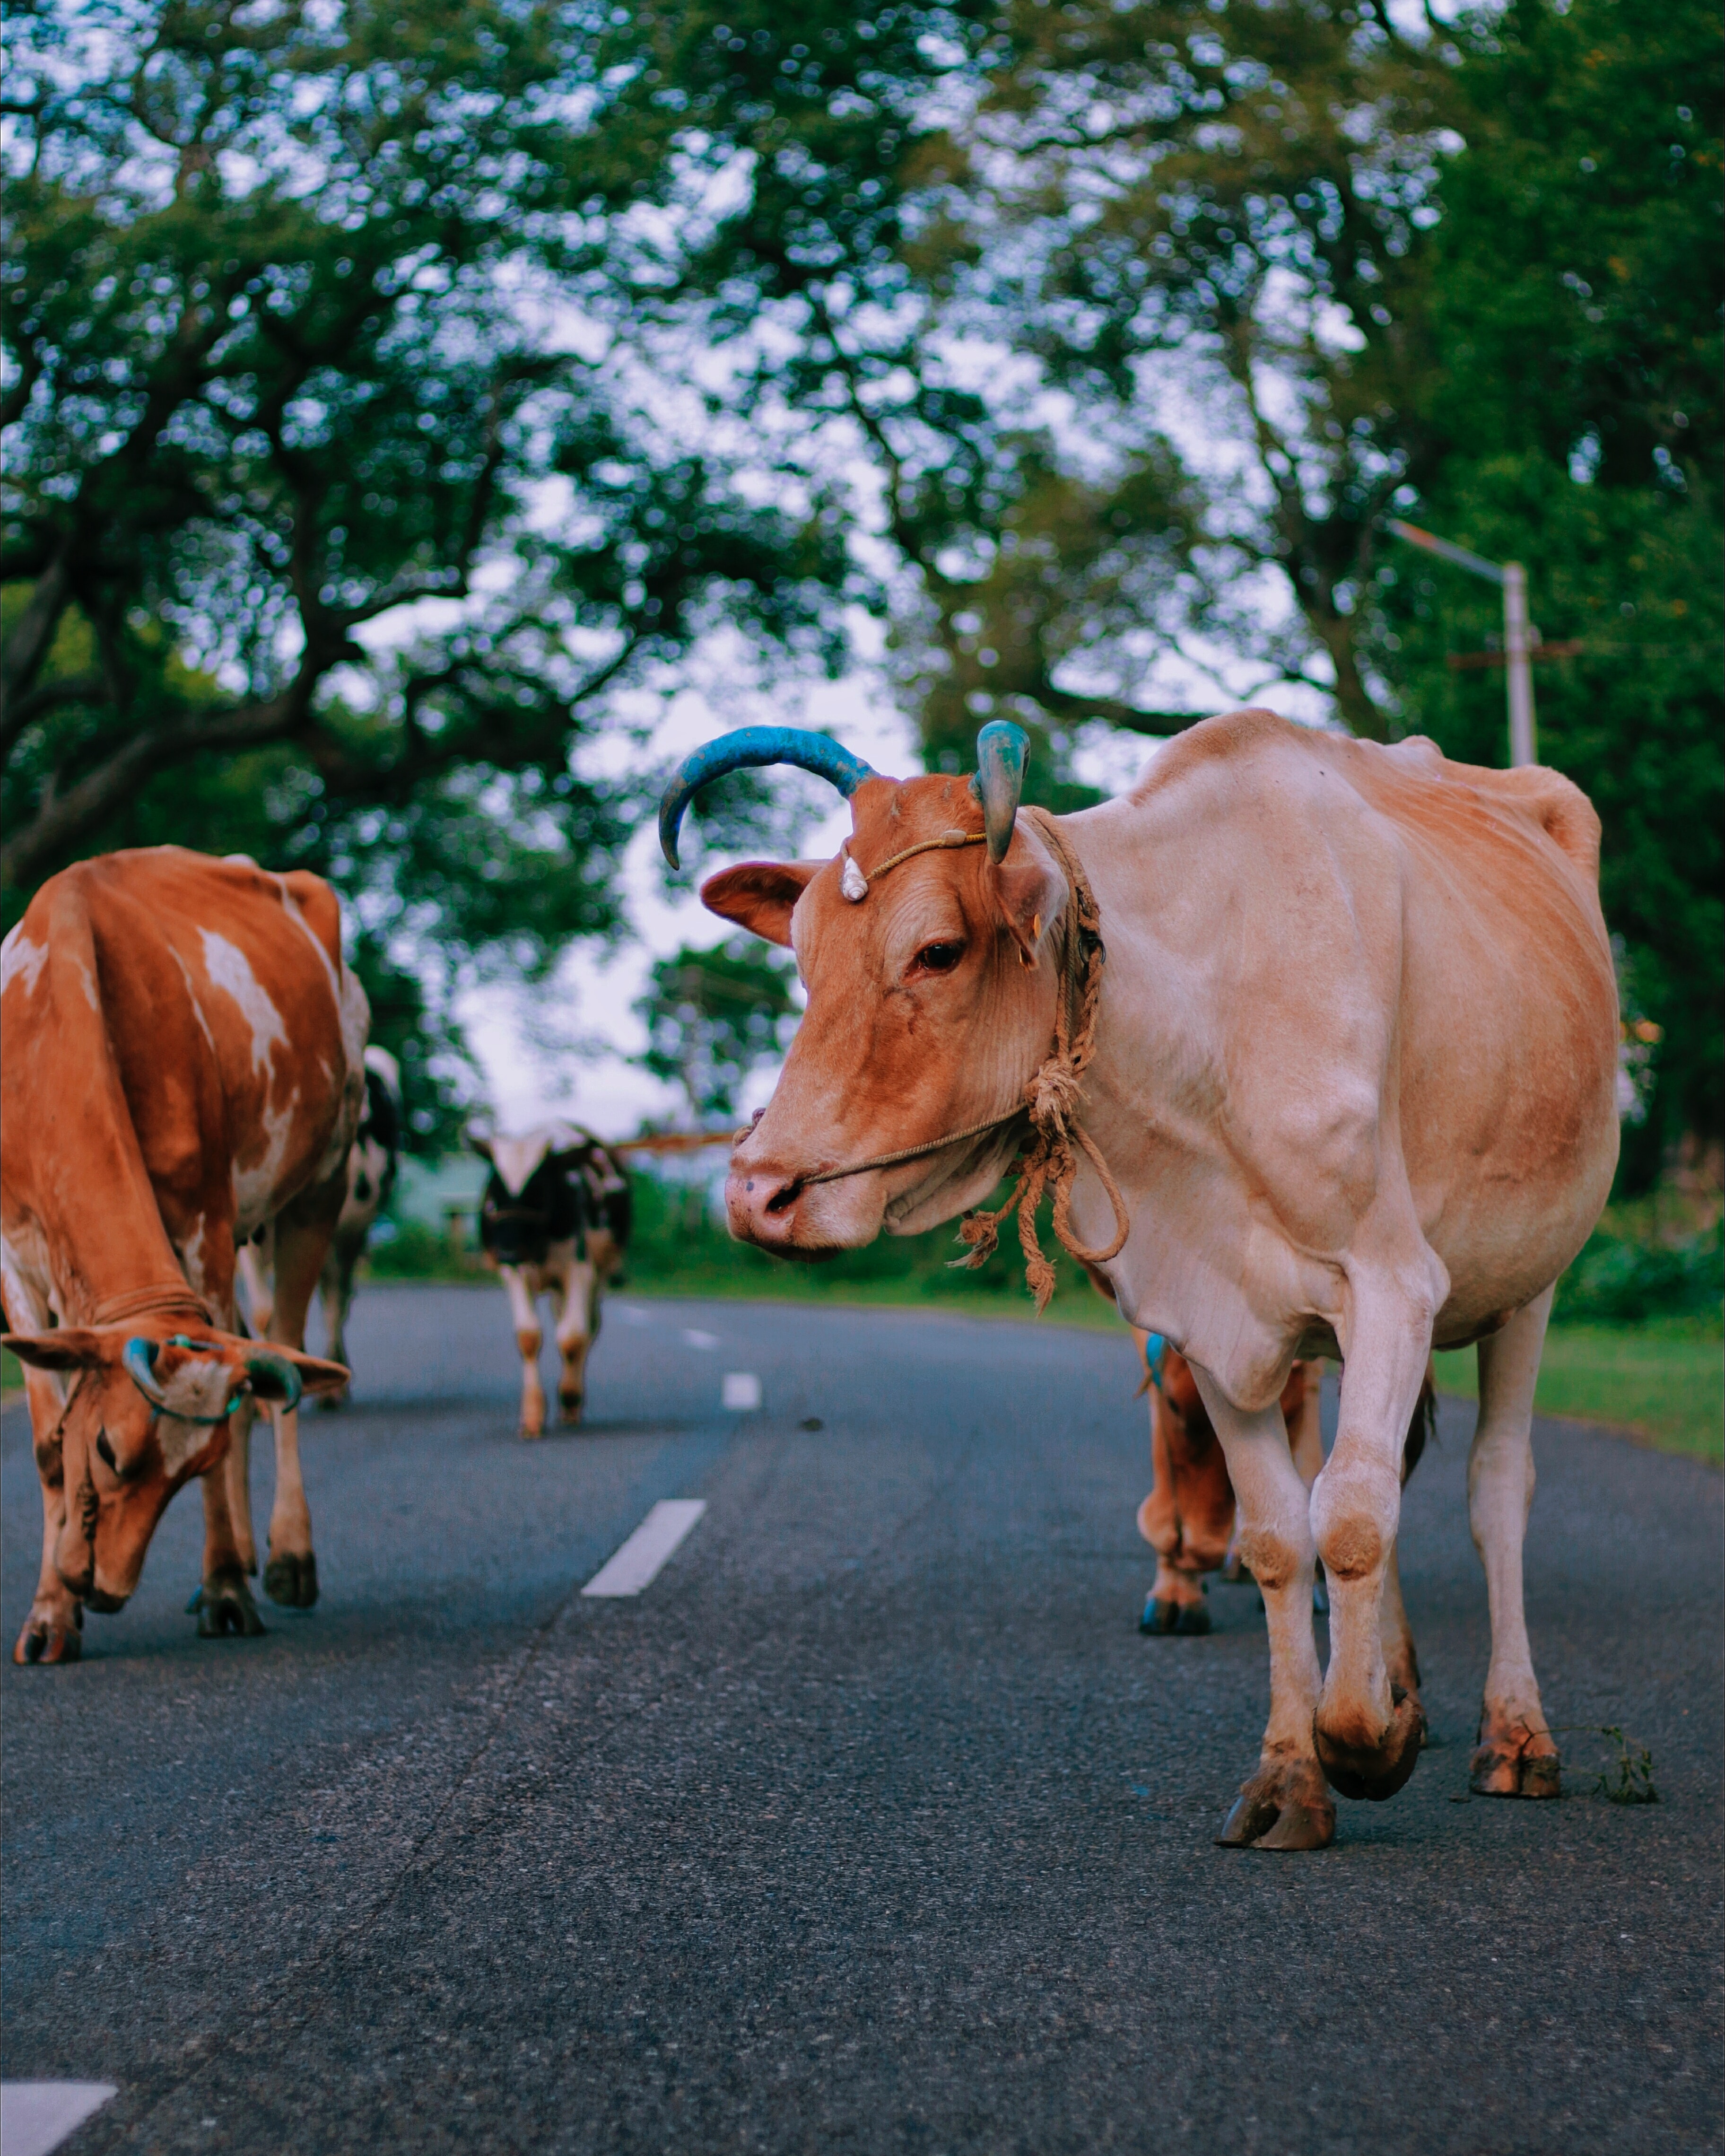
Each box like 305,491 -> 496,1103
1468,1289 -> 1561,1796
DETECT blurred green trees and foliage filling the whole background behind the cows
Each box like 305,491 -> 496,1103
0,0 -> 1725,1449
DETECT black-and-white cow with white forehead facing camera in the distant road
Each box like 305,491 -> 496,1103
468,1123 -> 630,1438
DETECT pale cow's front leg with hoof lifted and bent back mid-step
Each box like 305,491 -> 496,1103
1311,1285 -> 1436,1798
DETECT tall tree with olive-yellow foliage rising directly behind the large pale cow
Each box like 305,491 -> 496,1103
625,0 -> 1455,802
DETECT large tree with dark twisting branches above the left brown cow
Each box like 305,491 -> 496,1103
0,0 -> 850,960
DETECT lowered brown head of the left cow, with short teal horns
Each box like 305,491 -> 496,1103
4,1326 -> 349,1611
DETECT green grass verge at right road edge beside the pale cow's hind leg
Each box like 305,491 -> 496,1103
1438,1318 -> 1725,1466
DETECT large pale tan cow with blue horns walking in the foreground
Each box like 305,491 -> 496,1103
660,711 -> 1617,1848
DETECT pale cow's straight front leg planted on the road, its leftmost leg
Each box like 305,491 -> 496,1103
1193,1367 -> 1335,1850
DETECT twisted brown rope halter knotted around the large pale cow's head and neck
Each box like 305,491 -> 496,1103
784,809 -> 1132,1318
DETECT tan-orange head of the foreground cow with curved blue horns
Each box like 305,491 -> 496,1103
660,722 -> 1067,1257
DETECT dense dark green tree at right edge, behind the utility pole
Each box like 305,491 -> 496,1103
1363,0 -> 1725,1190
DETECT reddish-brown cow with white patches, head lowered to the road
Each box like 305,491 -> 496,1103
0,845 -> 366,1662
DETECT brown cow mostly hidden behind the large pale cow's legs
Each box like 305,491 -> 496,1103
1132,1326 -> 1438,1712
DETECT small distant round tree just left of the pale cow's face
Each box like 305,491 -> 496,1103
636,936 -> 796,1121
